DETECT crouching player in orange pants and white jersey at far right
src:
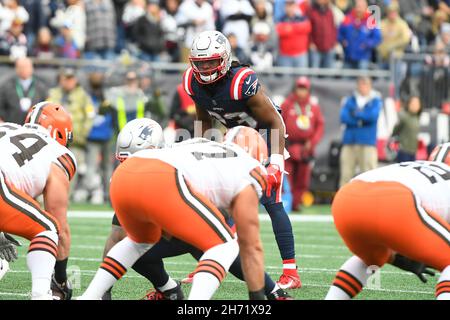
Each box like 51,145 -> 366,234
326,143 -> 450,300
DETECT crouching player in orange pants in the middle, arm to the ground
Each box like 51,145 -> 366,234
81,129 -> 267,300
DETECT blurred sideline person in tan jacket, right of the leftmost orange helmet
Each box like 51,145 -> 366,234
47,68 -> 95,202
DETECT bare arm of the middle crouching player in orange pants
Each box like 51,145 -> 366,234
232,186 -> 264,299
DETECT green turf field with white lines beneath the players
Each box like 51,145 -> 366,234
0,206 -> 438,300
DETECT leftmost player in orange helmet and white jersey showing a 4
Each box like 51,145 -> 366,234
0,102 -> 76,300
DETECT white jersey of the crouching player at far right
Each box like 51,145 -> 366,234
353,161 -> 450,223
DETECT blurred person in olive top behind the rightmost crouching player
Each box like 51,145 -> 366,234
392,96 -> 422,162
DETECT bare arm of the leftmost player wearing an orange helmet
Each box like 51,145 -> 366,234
44,164 -> 70,260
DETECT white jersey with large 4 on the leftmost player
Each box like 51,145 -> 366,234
0,123 -> 76,198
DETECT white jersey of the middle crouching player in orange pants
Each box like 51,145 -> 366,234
132,139 -> 267,208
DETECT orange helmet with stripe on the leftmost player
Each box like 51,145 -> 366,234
25,101 -> 73,147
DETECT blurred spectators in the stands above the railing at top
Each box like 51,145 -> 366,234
0,0 -> 450,69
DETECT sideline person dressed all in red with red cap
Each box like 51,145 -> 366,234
281,77 -> 324,211
